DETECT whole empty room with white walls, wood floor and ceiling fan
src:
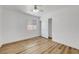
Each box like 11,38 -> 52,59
0,5 -> 79,54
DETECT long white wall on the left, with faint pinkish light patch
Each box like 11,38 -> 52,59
2,7 -> 40,44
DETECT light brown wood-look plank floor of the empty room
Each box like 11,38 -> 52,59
0,37 -> 79,54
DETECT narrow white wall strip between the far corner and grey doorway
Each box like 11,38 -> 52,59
41,15 -> 48,38
